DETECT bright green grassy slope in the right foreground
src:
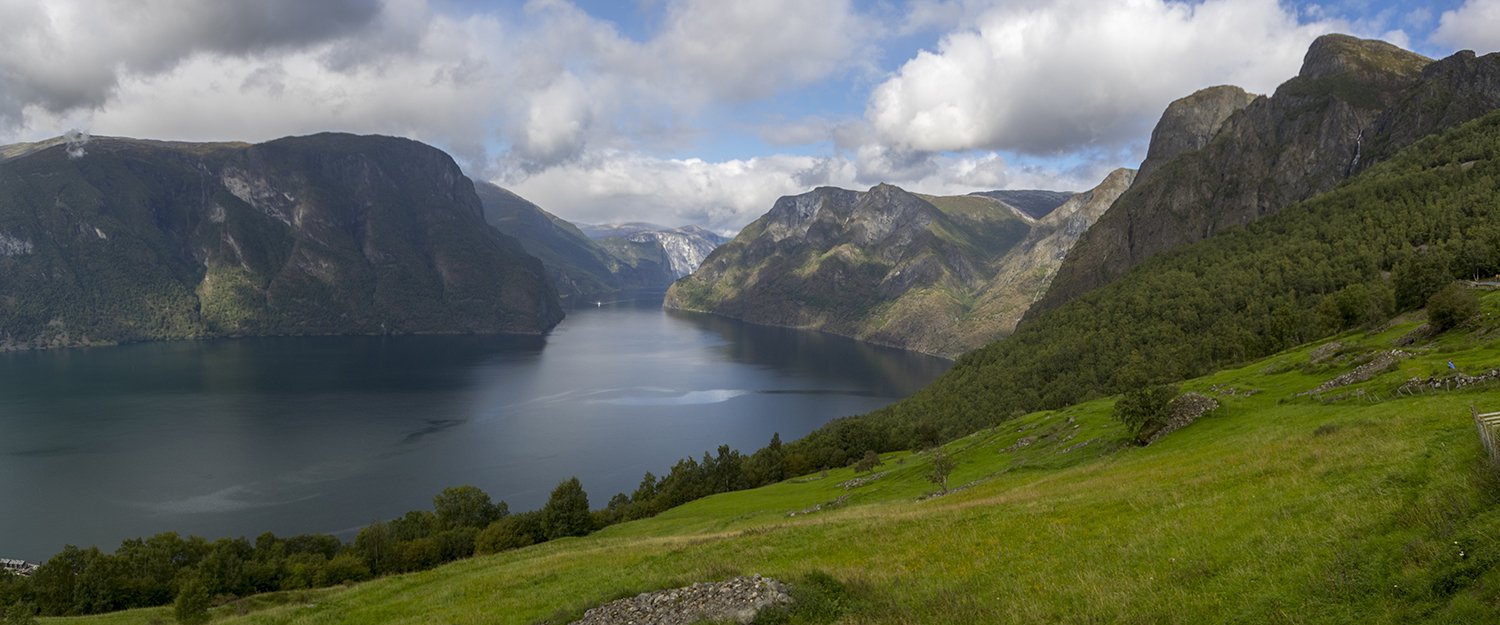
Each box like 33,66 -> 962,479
58,294 -> 1500,625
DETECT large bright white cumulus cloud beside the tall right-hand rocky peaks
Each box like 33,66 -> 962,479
866,0 -> 1340,154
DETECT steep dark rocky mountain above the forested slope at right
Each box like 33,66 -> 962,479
1028,34 -> 1500,318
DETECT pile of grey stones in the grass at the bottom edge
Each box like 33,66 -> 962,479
572,576 -> 792,625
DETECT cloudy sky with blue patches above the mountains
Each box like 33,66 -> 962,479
0,0 -> 1500,231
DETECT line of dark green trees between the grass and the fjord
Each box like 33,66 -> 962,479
0,435 -> 810,622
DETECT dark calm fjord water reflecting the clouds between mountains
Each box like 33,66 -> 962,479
0,297 -> 948,561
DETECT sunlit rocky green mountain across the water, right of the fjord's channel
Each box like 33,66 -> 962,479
666,177 -> 1131,357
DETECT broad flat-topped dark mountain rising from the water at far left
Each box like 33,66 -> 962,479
0,133 -> 563,349
